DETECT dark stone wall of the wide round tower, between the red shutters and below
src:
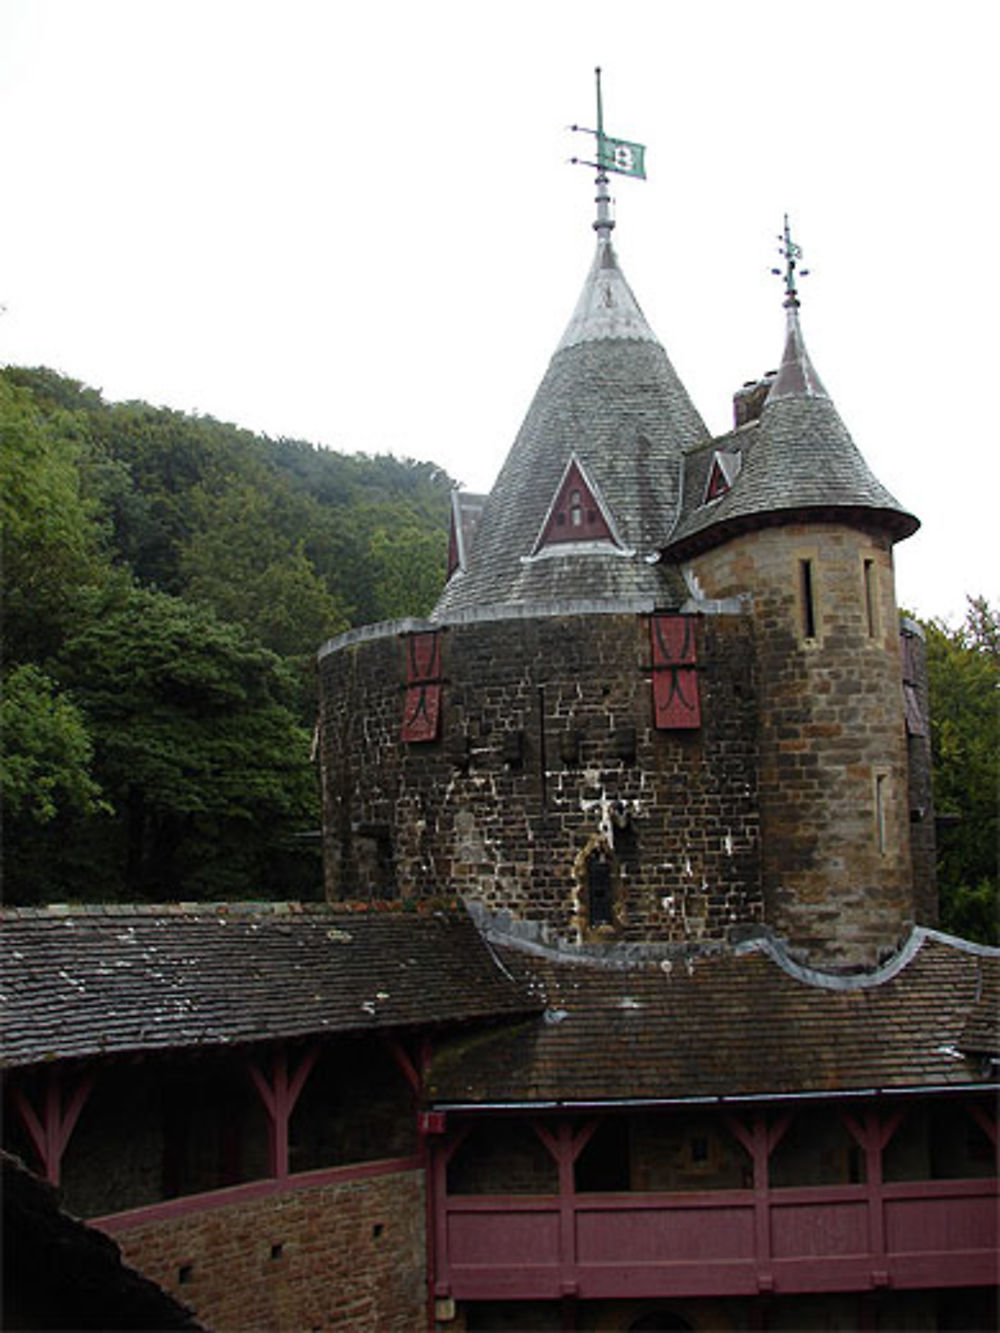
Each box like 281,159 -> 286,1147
320,613 -> 761,942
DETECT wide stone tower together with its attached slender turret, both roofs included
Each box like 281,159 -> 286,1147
320,194 -> 933,965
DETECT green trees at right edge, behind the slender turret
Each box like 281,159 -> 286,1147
924,597 -> 1000,944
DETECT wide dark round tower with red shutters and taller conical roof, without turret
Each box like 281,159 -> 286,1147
320,172 -> 761,948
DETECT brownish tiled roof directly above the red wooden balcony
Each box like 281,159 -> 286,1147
431,933 -> 1000,1105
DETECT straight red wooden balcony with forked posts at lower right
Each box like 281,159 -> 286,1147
432,1109 -> 999,1300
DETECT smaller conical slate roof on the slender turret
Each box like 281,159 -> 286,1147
665,303 -> 919,557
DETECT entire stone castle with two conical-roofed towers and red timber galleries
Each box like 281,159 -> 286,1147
3,148 -> 1000,1333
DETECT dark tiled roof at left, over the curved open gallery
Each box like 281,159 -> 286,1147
0,904 -> 541,1065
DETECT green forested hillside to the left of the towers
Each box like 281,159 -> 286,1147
0,368 -> 451,902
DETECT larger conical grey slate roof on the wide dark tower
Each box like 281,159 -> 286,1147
433,232 -> 708,619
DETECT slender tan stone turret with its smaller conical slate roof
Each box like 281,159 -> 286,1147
665,224 -> 917,964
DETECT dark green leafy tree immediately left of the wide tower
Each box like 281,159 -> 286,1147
7,588 -> 320,901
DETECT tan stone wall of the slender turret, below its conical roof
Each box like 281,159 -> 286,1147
692,523 -> 915,965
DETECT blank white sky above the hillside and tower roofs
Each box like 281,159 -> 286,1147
0,0 -> 1000,621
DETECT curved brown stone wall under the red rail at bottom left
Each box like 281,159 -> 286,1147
113,1172 -> 427,1333
